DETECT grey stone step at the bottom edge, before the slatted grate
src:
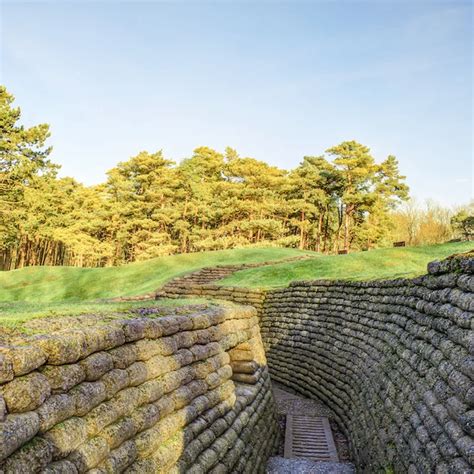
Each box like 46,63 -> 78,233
265,456 -> 356,474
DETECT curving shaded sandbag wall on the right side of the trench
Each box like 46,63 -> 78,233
261,258 -> 474,474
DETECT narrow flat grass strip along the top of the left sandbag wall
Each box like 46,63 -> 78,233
0,298 -> 209,331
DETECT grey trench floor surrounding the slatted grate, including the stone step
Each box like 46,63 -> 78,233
267,381 -> 355,474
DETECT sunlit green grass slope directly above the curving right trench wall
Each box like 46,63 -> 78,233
222,242 -> 474,288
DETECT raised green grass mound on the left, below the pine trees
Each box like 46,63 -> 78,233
0,248 -> 309,302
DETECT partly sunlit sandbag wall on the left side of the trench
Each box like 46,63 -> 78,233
0,306 -> 278,474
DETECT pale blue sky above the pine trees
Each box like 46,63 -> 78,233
0,0 -> 474,206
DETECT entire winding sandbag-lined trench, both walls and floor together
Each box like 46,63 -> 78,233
0,256 -> 474,474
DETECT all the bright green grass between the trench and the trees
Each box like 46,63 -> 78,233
0,242 -> 473,331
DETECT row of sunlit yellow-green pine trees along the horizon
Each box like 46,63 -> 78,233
0,87 -> 472,270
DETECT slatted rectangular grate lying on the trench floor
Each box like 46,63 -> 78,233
284,415 -> 339,462
